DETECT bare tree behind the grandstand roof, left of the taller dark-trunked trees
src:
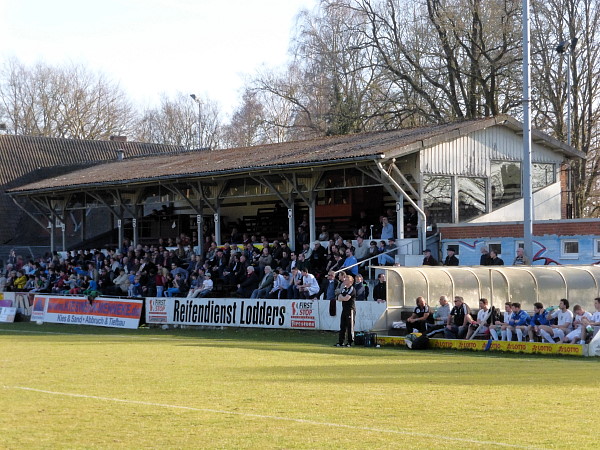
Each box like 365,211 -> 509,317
254,0 -> 392,139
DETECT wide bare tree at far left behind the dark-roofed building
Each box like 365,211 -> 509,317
0,59 -> 135,139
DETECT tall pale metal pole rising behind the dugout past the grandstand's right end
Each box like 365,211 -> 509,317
523,0 -> 533,259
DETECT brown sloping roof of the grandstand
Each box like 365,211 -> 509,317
10,116 -> 585,194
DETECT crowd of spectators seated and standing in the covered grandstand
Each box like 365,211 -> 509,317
0,216 -> 404,300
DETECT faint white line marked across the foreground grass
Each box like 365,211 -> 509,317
4,386 -> 539,449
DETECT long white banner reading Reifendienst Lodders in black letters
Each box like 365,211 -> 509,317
146,297 -> 385,331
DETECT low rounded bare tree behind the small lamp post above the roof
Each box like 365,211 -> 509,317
135,93 -> 221,149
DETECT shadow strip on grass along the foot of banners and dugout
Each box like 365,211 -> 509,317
0,322 -> 600,373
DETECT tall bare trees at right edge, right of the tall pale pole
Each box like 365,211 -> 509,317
531,0 -> 600,217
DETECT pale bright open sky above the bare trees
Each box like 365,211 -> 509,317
0,0 -> 318,115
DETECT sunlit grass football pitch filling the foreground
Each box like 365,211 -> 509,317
0,323 -> 600,449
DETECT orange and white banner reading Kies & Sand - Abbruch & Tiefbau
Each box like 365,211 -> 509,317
32,295 -> 143,329
